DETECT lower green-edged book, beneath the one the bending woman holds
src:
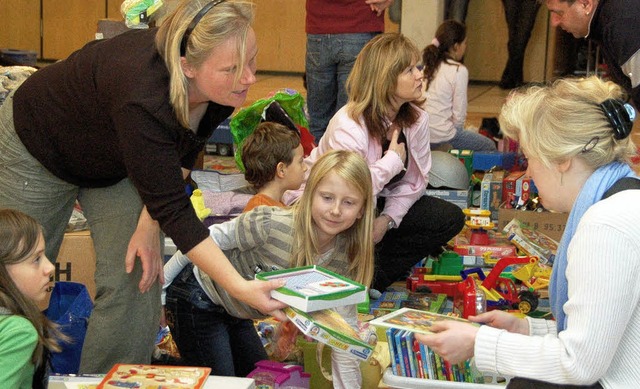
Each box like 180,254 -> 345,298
284,307 -> 375,361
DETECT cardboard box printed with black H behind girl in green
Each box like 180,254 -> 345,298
54,230 -> 96,299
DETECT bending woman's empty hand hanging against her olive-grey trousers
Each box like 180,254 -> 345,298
125,207 -> 164,293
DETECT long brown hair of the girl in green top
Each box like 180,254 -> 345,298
0,209 -> 68,367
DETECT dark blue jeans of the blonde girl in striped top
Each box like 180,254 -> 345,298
166,264 -> 268,377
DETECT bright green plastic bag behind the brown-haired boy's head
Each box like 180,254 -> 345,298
229,89 -> 309,172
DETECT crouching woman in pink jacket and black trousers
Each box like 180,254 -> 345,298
288,33 -> 464,291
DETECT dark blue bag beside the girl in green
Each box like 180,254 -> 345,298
44,282 -> 93,374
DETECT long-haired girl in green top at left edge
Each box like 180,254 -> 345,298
0,209 -> 66,389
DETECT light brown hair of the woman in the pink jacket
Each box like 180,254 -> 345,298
346,33 -> 421,142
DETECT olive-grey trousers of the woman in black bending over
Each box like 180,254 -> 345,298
0,92 -> 160,373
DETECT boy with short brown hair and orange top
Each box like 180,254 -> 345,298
242,122 -> 307,212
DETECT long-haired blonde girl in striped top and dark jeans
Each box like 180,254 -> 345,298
164,150 -> 374,388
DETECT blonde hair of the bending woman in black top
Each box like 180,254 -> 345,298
156,0 -> 254,128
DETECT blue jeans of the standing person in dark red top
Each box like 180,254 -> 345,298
305,33 -> 378,141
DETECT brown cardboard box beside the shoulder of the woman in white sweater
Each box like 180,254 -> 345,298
497,208 -> 569,242
